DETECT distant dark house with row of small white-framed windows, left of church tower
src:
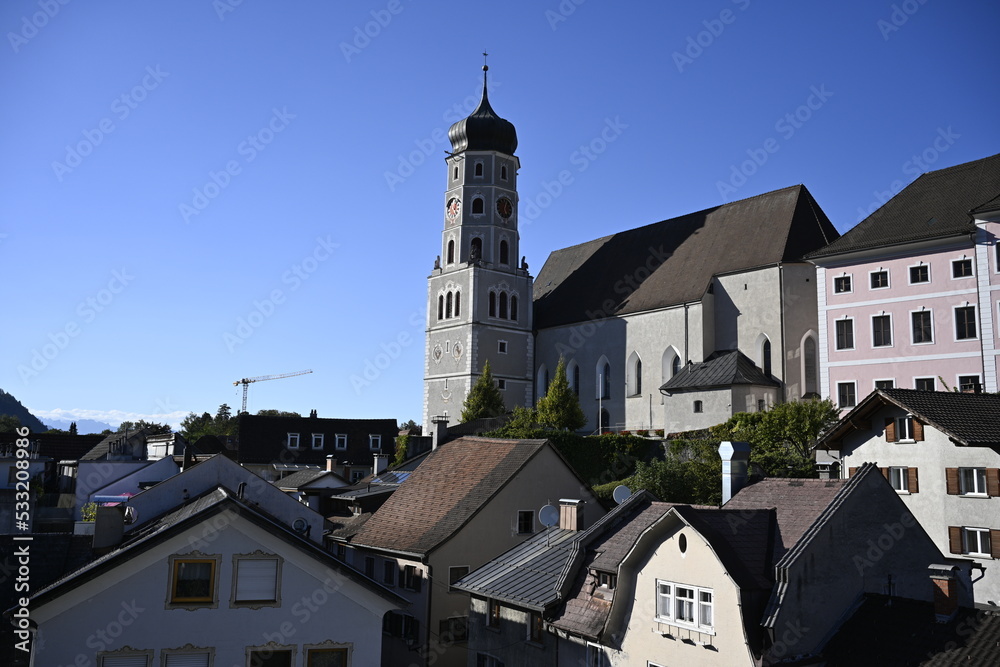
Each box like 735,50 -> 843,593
235,411 -> 399,482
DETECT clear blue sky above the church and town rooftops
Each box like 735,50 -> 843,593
0,0 -> 1000,434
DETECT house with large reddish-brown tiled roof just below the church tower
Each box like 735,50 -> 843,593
332,437 -> 604,665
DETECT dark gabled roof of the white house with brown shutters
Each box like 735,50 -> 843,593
816,389 -> 1000,449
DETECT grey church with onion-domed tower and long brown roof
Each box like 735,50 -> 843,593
423,66 -> 839,433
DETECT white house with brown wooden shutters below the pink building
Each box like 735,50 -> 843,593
816,389 -> 1000,609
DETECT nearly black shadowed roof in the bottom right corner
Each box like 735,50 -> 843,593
822,595 -> 1000,667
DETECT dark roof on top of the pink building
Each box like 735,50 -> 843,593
809,155 -> 1000,259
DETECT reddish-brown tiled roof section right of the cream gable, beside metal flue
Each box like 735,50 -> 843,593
723,478 -> 847,560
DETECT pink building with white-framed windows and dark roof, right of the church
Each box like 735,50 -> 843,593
807,155 -> 1000,409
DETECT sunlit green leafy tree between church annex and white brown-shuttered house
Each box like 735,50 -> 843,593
712,399 -> 840,477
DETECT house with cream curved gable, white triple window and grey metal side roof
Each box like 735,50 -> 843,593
456,452 -> 971,667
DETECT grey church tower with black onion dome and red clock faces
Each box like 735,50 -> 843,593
423,65 -> 534,433
